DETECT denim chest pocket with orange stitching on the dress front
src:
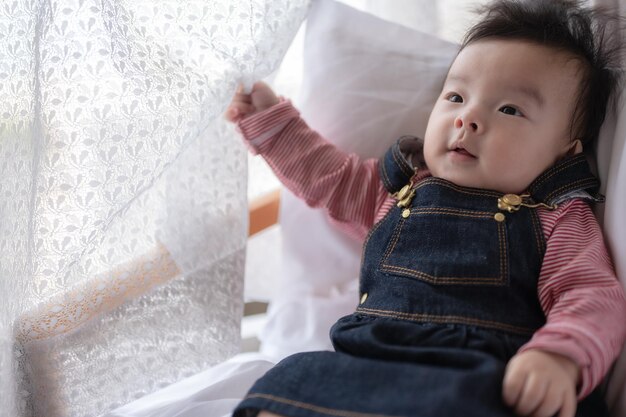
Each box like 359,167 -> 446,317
379,207 -> 509,286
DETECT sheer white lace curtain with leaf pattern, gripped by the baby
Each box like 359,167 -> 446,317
0,0 -> 307,417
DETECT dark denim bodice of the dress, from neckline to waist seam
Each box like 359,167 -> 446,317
357,177 -> 545,336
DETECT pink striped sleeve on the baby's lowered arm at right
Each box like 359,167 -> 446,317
520,200 -> 626,399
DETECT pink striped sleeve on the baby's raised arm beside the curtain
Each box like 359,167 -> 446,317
238,100 -> 388,239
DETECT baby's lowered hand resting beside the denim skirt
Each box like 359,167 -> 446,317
502,350 -> 579,417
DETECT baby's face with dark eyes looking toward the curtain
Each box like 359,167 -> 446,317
424,39 -> 580,193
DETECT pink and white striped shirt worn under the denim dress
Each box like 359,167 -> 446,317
239,101 -> 626,399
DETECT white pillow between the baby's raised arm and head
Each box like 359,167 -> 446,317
297,0 -> 458,157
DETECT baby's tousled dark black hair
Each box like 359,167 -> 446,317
461,0 -> 623,143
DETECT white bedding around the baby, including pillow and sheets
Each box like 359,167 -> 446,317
105,0 -> 626,417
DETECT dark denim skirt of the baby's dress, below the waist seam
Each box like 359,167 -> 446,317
234,322 -> 608,417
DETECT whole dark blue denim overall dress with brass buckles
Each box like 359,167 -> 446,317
234,142 -> 608,417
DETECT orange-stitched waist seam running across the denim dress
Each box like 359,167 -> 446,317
356,307 -> 535,335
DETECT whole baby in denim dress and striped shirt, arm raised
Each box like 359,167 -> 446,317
226,0 -> 626,417
